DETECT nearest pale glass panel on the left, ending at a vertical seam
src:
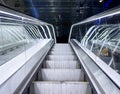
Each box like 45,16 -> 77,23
0,18 -> 26,65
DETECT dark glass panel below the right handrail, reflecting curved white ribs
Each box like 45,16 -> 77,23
71,9 -> 120,73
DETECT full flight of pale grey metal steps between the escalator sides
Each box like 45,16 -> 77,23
30,44 -> 92,94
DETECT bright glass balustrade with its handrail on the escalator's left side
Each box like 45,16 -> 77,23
0,6 -> 55,65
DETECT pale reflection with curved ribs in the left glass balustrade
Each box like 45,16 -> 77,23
0,20 -> 52,65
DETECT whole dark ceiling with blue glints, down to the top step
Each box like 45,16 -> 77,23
1,0 -> 120,42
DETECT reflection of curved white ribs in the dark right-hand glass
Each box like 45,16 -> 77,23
81,24 -> 120,72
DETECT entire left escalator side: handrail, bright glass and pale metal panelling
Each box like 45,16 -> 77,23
0,6 -> 56,94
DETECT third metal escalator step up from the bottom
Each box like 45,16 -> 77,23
45,61 -> 80,69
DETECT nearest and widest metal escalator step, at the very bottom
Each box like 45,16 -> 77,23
30,82 -> 92,94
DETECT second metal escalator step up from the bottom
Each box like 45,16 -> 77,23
39,69 -> 83,81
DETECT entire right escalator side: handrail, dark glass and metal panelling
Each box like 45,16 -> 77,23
68,5 -> 120,94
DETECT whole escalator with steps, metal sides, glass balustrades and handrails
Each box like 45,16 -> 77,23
0,6 -> 120,94
